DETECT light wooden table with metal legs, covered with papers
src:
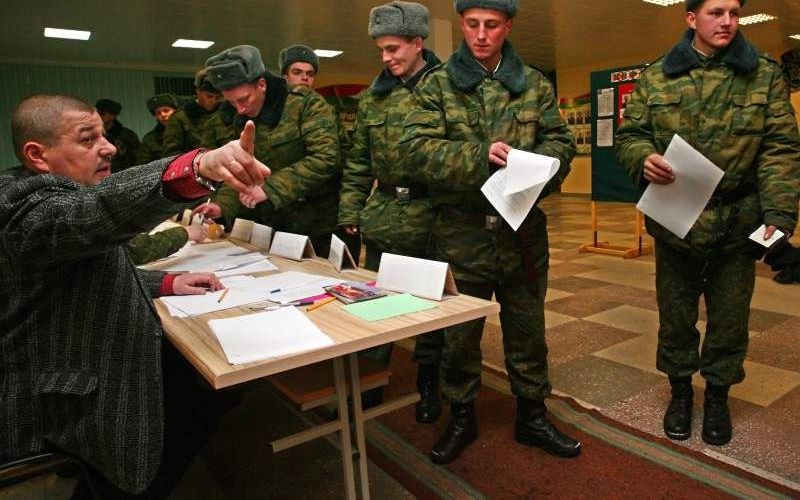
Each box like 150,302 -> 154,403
156,244 -> 500,499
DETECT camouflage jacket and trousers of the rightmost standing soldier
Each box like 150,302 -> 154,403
616,30 -> 800,386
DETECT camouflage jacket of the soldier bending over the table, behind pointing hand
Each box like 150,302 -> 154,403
204,74 -> 341,236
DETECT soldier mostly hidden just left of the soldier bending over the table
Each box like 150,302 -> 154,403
162,68 -> 221,158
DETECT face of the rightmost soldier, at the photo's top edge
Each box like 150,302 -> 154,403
686,0 -> 741,55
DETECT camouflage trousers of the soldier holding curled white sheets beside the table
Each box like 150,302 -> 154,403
439,271 -> 551,403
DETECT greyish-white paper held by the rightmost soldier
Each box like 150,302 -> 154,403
636,134 -> 725,239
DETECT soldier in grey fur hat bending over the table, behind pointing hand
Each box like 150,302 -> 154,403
196,45 -> 341,256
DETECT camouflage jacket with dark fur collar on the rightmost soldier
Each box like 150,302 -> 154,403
615,30 -> 800,255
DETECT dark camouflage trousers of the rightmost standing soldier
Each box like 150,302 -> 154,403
656,240 -> 755,385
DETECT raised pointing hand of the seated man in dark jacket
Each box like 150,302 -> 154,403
198,120 -> 271,193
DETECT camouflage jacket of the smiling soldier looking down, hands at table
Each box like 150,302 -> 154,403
339,50 -> 440,255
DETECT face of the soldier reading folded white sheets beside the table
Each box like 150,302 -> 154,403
461,8 -> 514,70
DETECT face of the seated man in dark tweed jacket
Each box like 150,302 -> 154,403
29,111 -> 117,186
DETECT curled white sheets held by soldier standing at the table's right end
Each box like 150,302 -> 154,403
481,149 -> 561,231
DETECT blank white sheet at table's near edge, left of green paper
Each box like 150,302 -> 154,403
208,307 -> 334,365
